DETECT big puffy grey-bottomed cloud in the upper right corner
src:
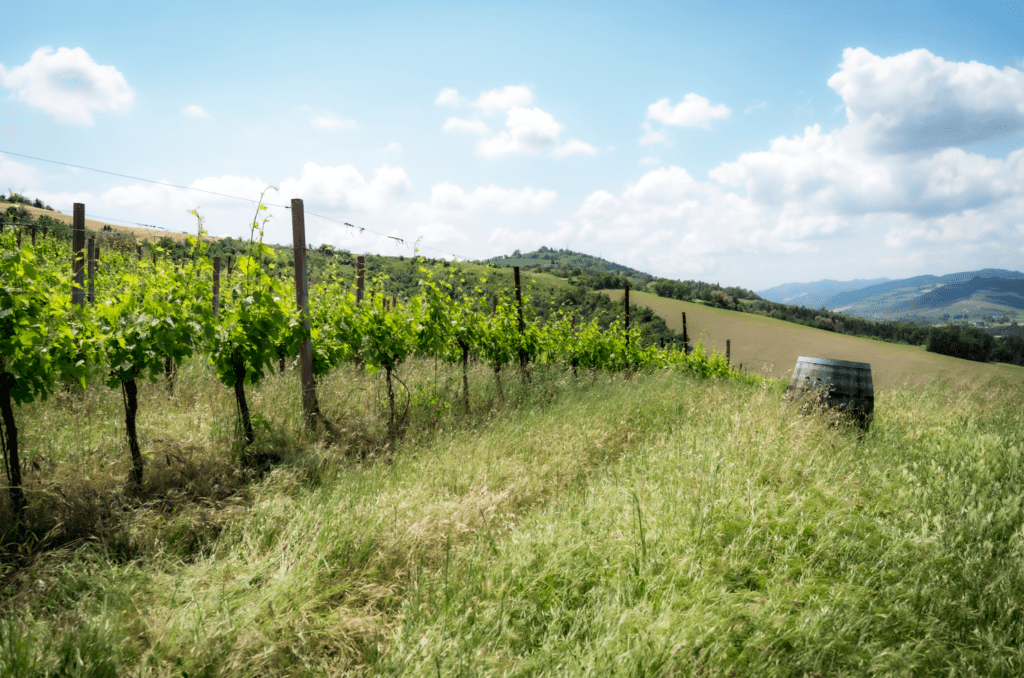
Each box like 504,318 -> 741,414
828,47 -> 1024,153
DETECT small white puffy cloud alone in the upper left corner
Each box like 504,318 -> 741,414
0,47 -> 135,125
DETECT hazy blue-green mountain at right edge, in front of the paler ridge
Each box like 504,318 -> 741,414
824,268 -> 1024,323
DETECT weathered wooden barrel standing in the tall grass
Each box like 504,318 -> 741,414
788,355 -> 874,429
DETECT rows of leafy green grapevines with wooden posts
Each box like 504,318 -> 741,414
0,201 -> 753,516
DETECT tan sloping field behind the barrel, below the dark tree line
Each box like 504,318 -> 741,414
605,290 -> 1024,390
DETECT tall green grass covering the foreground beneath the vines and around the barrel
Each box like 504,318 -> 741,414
0,356 -> 1024,676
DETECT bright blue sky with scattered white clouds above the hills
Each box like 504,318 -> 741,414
0,0 -> 1024,290
